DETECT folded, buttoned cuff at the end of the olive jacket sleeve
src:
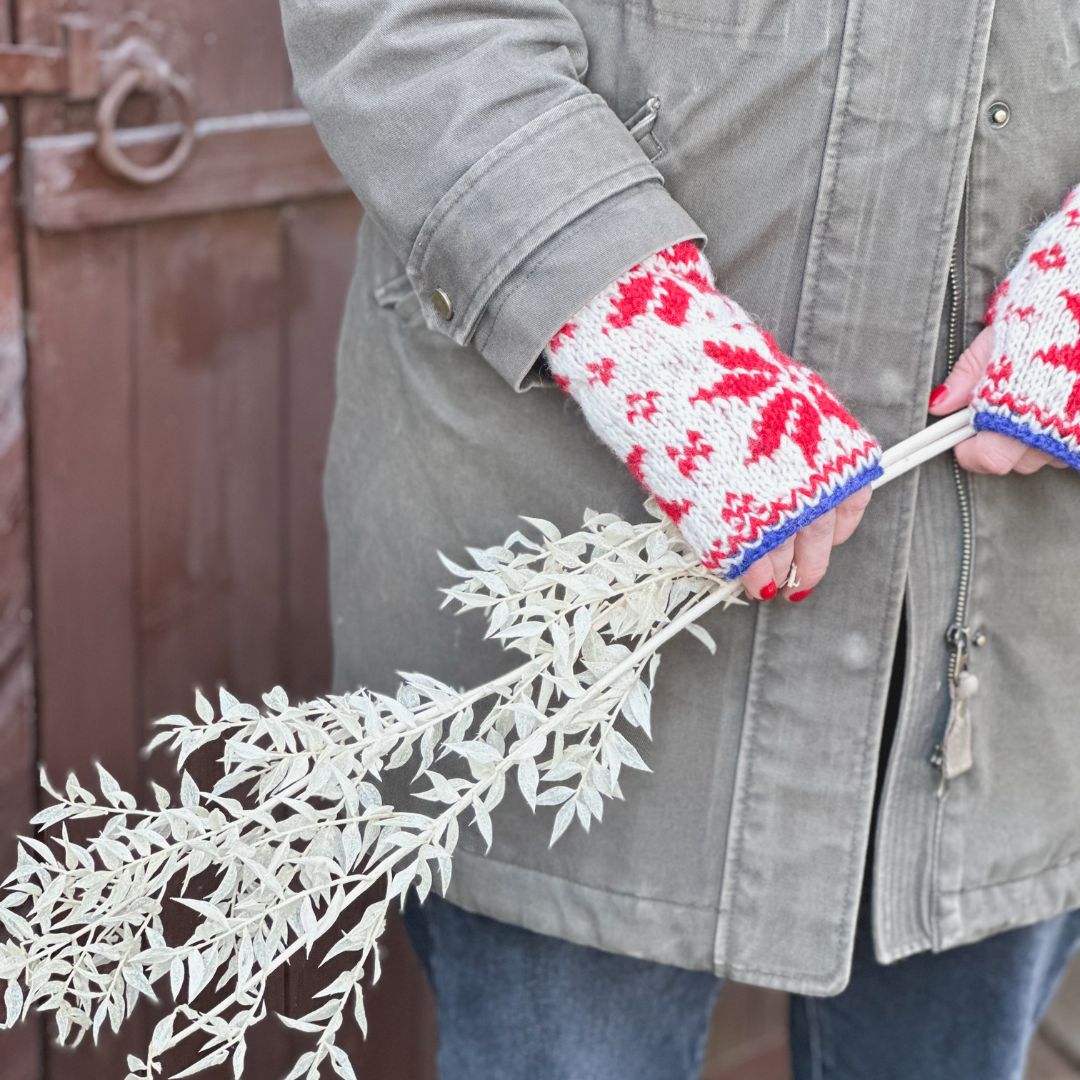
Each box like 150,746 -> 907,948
406,93 -> 704,389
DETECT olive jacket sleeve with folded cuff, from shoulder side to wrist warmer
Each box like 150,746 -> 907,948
281,0 -> 704,390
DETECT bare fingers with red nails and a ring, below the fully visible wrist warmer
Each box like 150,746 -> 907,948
739,487 -> 870,604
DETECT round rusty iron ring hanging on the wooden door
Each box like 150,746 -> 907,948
96,67 -> 195,187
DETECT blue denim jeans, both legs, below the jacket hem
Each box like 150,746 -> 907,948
405,613 -> 1080,1080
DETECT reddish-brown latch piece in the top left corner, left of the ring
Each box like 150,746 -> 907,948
0,15 -> 102,102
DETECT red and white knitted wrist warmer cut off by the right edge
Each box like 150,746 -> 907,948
972,187 -> 1080,469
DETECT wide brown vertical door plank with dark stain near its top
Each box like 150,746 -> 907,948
133,211 -> 284,718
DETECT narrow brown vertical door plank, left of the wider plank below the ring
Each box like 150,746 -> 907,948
28,223 -> 141,1080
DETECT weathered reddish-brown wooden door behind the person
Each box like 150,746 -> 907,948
0,0 -> 431,1080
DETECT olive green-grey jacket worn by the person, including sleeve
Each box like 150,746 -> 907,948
282,0 -> 1080,995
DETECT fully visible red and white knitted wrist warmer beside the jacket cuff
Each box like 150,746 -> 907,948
544,241 -> 881,579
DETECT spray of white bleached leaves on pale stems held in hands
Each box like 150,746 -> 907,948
0,418 -> 970,1080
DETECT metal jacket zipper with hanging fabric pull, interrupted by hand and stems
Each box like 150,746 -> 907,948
930,179 -> 978,795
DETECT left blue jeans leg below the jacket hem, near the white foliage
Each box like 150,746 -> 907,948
405,894 -> 723,1080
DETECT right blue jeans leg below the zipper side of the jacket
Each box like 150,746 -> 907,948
791,906 -> 1080,1080
